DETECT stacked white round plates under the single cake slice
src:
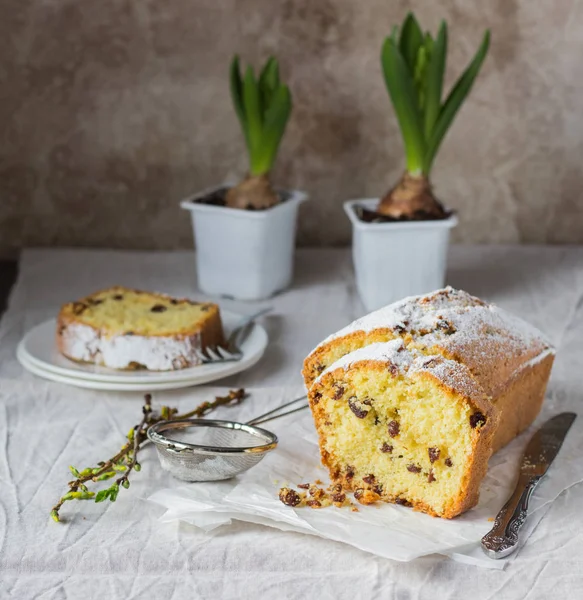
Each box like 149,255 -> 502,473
17,310 -> 267,391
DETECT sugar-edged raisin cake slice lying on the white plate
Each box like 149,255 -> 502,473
57,287 -> 223,371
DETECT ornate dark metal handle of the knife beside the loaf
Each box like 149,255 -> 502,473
482,476 -> 541,558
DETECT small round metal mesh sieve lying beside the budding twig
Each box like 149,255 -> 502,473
148,396 -> 308,481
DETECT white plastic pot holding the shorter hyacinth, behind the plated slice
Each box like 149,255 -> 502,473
180,185 -> 308,300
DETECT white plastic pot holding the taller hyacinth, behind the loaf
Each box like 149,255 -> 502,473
344,198 -> 457,311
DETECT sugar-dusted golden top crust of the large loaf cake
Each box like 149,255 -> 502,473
310,287 -> 554,397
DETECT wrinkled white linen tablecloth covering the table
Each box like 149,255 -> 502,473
0,247 -> 583,600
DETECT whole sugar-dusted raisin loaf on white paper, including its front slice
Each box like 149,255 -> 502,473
304,288 -> 554,518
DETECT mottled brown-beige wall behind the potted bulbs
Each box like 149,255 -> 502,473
0,0 -> 583,254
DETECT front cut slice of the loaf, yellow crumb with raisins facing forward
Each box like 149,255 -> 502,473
309,339 -> 498,518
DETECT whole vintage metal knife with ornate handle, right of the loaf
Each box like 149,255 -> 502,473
482,413 -> 577,558
